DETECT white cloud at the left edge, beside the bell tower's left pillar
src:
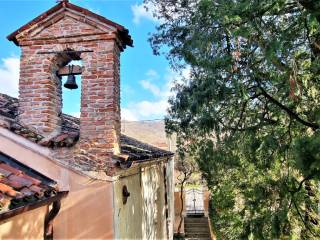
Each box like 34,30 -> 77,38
0,57 -> 20,97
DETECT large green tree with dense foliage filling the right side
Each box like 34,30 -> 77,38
146,0 -> 320,239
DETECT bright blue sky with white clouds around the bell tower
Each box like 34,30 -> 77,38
0,0 -> 185,120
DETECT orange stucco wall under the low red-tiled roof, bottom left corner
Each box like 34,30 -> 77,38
0,206 -> 47,240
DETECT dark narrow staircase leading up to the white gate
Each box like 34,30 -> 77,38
184,216 -> 211,240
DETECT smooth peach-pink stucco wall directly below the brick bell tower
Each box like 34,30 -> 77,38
0,133 -> 113,239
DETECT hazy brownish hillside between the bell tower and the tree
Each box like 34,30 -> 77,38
121,120 -> 175,151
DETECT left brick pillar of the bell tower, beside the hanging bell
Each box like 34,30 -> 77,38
19,45 -> 62,136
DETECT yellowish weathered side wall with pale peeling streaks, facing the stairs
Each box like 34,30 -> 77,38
114,162 -> 172,239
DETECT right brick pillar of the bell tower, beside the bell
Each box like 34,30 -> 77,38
79,42 -> 120,171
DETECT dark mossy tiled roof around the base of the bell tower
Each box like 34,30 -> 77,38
0,93 -> 173,161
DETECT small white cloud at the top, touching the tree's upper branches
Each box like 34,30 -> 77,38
131,3 -> 159,24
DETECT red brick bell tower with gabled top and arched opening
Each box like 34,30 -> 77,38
8,0 -> 132,172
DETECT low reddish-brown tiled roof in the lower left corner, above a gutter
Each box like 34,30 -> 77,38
0,152 -> 58,215
